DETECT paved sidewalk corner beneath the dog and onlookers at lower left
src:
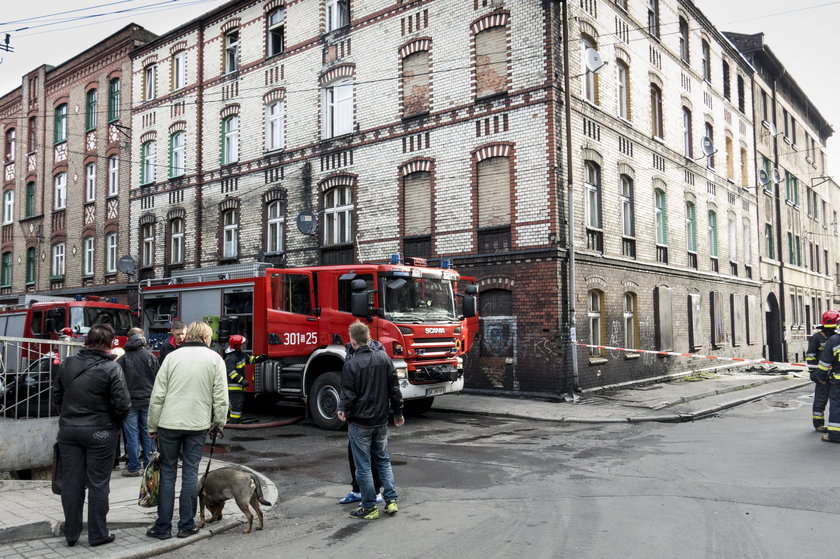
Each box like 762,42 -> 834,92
0,457 -> 277,559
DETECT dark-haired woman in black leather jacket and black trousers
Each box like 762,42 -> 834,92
53,324 -> 131,547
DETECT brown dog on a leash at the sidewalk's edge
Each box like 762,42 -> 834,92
198,468 -> 271,534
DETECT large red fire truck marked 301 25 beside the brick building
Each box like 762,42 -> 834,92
140,259 -> 477,429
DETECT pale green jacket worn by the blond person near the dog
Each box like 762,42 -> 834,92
149,342 -> 229,433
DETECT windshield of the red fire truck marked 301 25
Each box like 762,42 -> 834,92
381,276 -> 457,322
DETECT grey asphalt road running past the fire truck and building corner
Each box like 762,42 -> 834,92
162,389 -> 840,559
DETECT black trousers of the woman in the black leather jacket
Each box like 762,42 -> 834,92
58,425 -> 119,543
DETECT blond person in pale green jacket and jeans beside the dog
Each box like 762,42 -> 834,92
146,322 -> 228,540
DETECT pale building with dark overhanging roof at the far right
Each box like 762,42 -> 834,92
726,33 -> 840,368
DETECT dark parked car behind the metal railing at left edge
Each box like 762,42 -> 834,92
0,354 -> 59,419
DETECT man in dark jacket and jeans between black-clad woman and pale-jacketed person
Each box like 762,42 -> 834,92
117,328 -> 160,477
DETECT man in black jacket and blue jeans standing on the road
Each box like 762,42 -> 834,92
338,321 -> 405,520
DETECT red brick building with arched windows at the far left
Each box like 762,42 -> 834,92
0,25 -> 154,303
